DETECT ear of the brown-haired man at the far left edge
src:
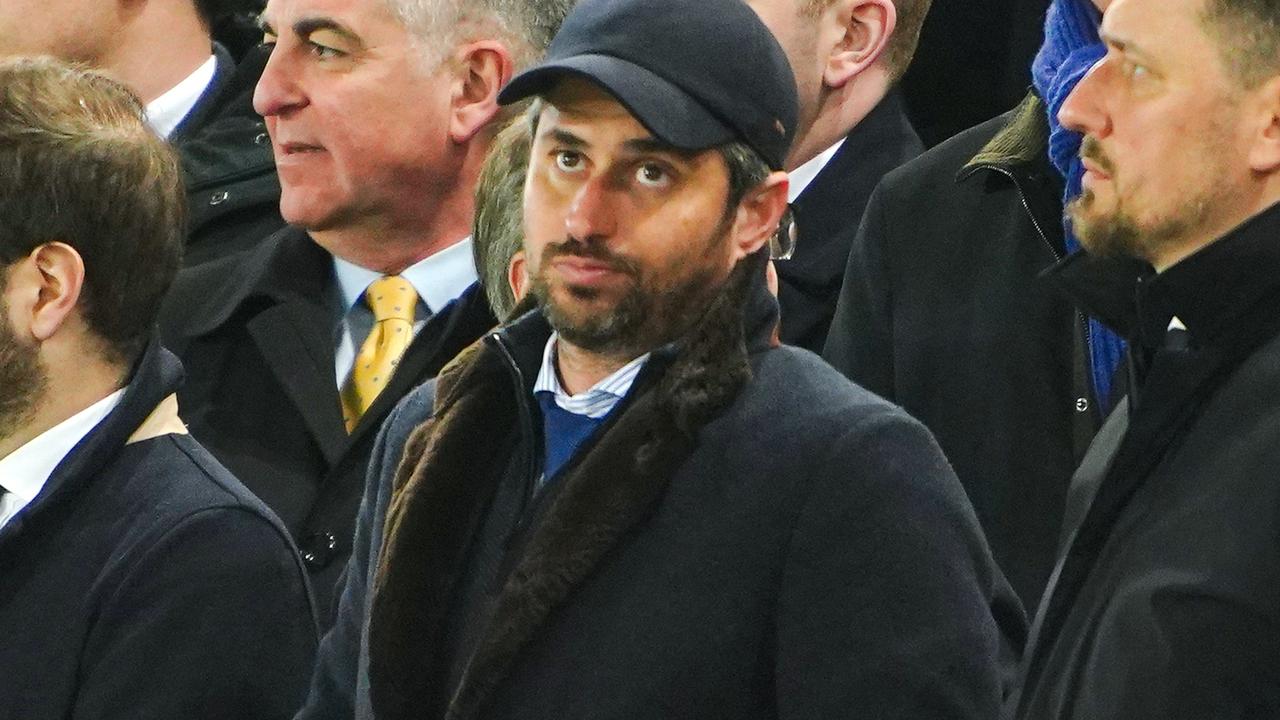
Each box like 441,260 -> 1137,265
5,242 -> 84,342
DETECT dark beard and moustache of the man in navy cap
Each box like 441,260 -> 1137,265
530,237 -> 722,357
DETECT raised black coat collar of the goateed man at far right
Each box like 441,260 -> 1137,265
1044,198 -> 1280,350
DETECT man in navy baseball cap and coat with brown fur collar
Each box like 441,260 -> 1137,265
300,0 -> 1023,720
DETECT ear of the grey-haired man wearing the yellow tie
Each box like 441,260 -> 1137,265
449,40 -> 516,145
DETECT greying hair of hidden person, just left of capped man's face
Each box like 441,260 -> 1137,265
471,120 -> 531,320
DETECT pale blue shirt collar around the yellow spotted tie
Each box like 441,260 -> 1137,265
333,237 -> 479,313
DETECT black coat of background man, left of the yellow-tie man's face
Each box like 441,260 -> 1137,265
169,45 -> 284,266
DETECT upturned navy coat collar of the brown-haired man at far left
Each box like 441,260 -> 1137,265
0,338 -> 183,539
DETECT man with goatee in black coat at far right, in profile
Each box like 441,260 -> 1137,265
1016,0 -> 1280,707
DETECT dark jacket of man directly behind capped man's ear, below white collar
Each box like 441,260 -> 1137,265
777,92 -> 924,352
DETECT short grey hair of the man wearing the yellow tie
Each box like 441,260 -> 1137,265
387,0 -> 576,68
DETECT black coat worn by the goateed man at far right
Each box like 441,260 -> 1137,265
1016,205 -> 1280,720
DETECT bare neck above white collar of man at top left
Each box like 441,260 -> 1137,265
96,3 -> 212,102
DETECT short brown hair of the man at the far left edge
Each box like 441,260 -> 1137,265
0,58 -> 186,364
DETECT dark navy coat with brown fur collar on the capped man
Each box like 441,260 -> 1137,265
298,265 -> 1024,720
